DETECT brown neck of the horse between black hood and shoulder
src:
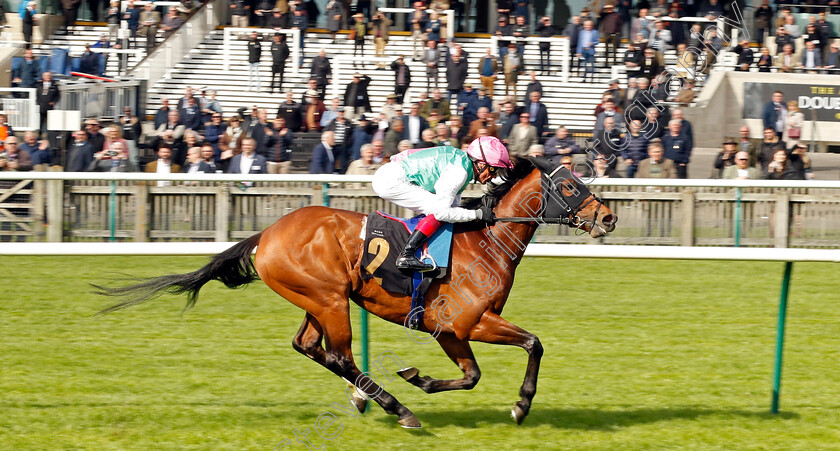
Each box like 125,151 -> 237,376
482,169 -> 542,263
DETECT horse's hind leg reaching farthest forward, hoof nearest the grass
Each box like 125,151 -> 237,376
304,301 -> 420,428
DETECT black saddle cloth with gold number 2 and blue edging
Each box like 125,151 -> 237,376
362,211 -> 454,295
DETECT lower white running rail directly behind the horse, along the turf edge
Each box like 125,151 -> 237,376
0,242 -> 840,263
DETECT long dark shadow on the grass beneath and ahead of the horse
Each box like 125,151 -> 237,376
406,407 -> 799,431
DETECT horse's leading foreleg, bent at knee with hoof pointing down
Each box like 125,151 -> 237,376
469,313 -> 543,424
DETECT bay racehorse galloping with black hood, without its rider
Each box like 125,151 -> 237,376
96,158 -> 617,428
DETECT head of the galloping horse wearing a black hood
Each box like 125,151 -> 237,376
529,158 -> 618,238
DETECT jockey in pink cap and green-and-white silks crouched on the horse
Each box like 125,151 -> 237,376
373,136 -> 513,271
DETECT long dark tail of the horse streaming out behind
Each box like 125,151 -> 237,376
93,232 -> 262,315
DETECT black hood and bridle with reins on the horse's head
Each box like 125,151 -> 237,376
496,165 -> 606,233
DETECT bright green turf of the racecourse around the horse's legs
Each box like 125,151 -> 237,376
0,257 -> 840,450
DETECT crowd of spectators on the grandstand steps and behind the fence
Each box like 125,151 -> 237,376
0,0 -> 838,183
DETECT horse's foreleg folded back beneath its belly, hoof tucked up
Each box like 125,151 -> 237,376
397,333 -> 481,393
